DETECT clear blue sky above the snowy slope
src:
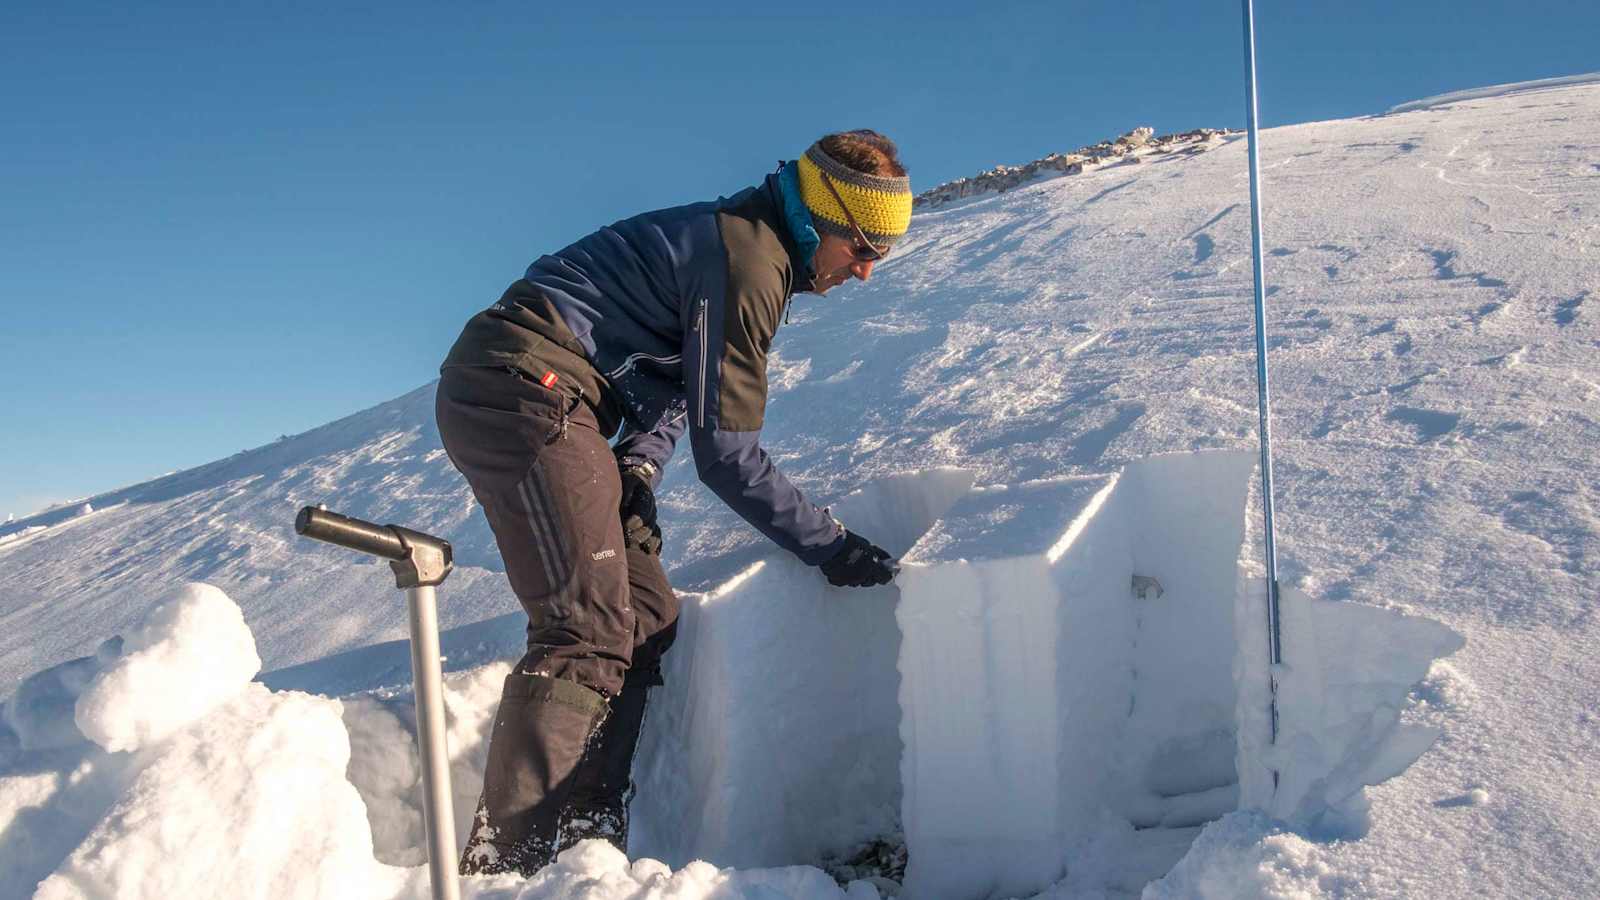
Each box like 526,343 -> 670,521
0,0 -> 1600,519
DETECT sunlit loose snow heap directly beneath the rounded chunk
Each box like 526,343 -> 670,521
35,679 -> 422,900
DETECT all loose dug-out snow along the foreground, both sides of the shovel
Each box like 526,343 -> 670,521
0,585 -> 878,900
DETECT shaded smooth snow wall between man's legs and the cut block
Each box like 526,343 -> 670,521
629,469 -> 973,866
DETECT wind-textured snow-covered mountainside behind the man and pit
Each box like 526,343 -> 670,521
0,76 -> 1600,897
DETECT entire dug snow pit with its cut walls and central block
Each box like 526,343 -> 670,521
630,452 -> 1458,898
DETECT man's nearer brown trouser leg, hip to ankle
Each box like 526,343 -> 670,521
437,361 -> 637,874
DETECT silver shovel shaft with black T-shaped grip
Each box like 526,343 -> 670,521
294,506 -> 459,900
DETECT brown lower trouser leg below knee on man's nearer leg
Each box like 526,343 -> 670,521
461,673 -> 606,878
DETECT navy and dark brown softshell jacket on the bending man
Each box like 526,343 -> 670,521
432,175 -> 843,565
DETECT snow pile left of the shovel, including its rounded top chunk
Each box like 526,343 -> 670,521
0,585 -> 414,900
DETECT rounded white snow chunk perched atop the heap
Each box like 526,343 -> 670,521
75,583 -> 261,751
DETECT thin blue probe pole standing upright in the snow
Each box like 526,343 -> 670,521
1243,0 -> 1283,788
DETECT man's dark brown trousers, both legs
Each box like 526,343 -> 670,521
435,367 -> 678,874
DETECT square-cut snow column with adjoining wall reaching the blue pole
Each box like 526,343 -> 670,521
898,453 -> 1253,897
